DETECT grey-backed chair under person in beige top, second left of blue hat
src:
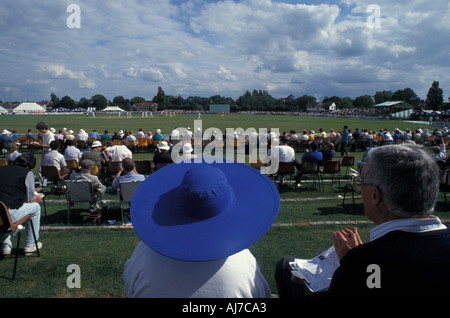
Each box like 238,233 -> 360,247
64,180 -> 101,224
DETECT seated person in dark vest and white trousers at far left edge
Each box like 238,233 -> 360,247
0,153 -> 42,255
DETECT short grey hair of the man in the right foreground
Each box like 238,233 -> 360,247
363,144 -> 440,217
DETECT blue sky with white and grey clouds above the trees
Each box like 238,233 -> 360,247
0,0 -> 450,102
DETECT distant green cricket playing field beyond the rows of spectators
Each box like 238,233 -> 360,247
0,114 -> 424,134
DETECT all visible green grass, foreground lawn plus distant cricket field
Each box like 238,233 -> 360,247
0,114 -> 448,298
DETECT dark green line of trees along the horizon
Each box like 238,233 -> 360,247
50,81 -> 450,112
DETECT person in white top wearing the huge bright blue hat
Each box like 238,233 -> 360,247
124,161 -> 280,298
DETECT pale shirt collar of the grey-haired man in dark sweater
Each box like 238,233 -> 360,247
370,216 -> 447,241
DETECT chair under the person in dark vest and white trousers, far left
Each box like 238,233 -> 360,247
0,201 -> 41,280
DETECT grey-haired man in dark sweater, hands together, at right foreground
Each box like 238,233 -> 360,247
275,143 -> 450,299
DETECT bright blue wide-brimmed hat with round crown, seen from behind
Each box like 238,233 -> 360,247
131,159 -> 280,261
